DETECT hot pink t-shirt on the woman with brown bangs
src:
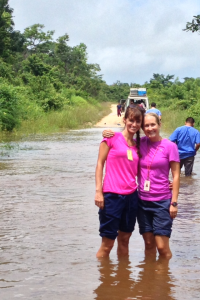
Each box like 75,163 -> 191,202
102,132 -> 139,195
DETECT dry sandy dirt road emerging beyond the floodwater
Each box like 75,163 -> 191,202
95,104 -> 124,128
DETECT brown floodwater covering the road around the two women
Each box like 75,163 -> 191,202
0,128 -> 200,300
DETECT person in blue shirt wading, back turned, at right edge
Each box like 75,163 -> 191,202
169,117 -> 200,176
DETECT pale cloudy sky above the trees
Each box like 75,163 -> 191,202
9,0 -> 200,84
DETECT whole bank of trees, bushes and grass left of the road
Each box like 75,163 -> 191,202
0,0 -> 113,141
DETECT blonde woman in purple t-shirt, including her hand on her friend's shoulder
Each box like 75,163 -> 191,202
103,113 -> 180,259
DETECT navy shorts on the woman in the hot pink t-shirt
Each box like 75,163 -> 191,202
99,191 -> 138,240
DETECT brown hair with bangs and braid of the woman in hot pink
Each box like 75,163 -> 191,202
124,105 -> 145,157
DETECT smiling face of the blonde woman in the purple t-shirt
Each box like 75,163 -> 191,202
143,114 -> 161,142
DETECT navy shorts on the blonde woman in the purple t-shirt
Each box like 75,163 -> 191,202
137,199 -> 173,237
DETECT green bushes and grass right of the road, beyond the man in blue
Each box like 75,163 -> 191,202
145,74 -> 200,130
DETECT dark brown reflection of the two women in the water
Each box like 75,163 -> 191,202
94,255 -> 175,300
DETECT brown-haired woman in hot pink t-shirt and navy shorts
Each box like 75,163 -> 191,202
95,107 -> 144,258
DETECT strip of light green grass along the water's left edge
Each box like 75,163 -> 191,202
0,102 -> 111,142
